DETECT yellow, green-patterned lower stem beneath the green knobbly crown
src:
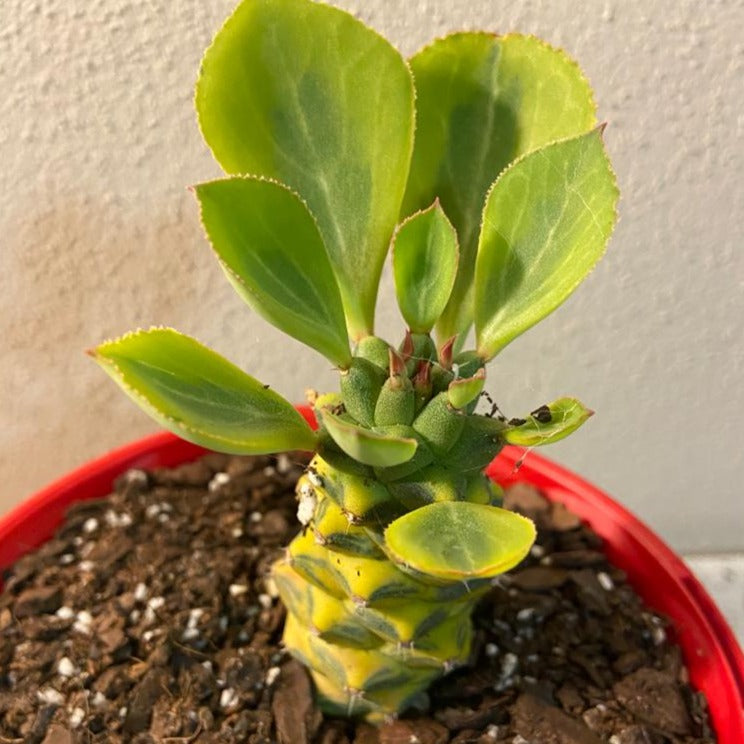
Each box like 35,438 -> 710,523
274,456 -> 497,720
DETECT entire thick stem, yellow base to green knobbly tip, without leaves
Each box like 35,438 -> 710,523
274,338 -> 529,720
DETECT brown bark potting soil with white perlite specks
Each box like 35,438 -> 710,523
0,455 -> 715,744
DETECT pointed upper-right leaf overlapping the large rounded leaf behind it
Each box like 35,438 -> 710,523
475,129 -> 618,359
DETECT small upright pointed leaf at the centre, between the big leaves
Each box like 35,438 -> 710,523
393,201 -> 458,333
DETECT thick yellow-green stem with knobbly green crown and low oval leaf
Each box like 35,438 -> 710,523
274,335 -> 534,721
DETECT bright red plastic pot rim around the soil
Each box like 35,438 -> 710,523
0,418 -> 744,744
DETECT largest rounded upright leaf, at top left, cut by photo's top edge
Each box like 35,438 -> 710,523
196,0 -> 414,340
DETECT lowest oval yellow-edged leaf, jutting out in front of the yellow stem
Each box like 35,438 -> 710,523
385,501 -> 535,581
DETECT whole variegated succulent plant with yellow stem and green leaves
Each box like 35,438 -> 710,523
92,0 -> 617,720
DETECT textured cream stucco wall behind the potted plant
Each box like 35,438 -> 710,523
0,0 -> 744,550
